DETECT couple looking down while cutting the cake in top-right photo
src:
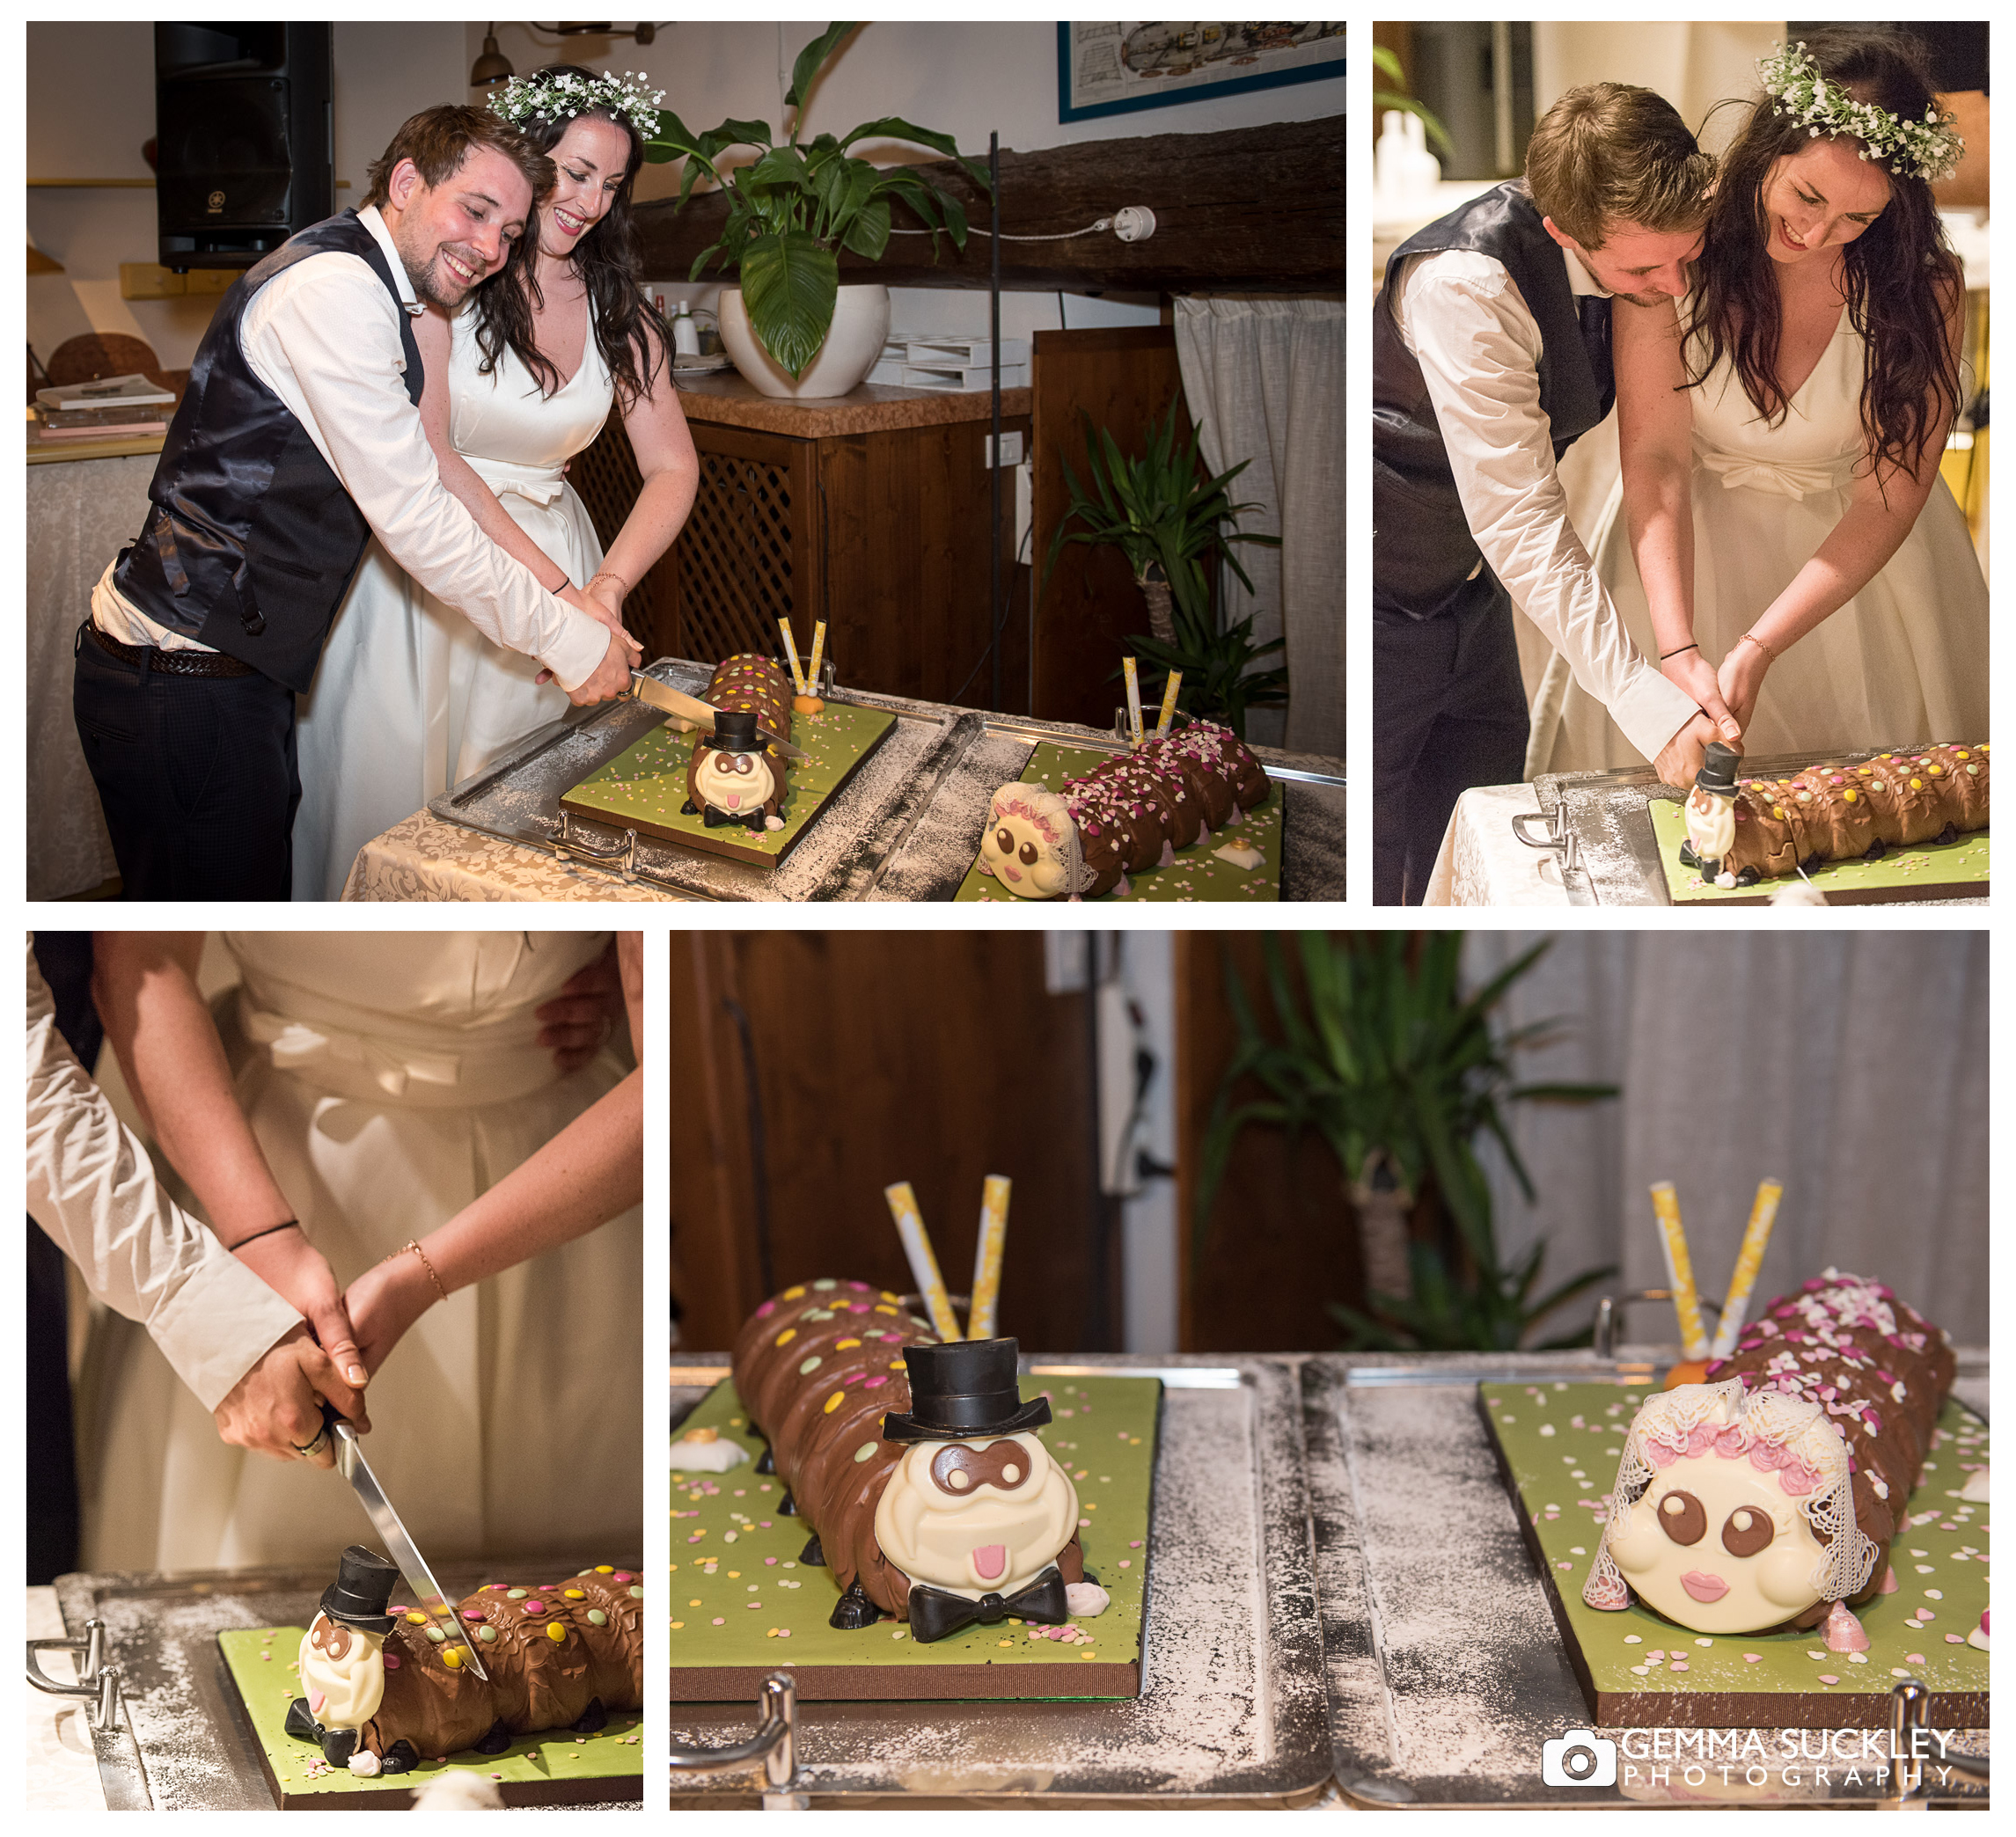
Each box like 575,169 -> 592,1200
1373,26 -> 1988,904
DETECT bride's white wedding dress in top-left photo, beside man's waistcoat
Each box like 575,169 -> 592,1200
294,311 -> 611,899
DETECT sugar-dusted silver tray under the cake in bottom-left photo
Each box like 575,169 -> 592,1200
56,1563 -> 641,1811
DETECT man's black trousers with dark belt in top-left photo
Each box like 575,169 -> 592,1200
70,627 -> 300,899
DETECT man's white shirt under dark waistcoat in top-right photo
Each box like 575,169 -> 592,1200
1389,250 -> 1697,760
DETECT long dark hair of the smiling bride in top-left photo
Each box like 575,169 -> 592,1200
476,64 -> 665,407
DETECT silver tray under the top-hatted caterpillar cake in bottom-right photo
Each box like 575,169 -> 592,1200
671,1358 -> 1331,1809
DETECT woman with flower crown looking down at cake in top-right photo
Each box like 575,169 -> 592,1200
1540,26 -> 1988,771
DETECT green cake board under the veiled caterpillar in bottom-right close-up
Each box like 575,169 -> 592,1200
1477,1381 -> 1988,1728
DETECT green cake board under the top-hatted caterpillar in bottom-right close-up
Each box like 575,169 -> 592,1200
670,1372 -> 1162,1702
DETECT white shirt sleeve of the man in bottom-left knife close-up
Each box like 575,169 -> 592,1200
28,933 -> 300,1409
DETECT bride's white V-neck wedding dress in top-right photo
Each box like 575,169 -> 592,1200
1528,304 -> 1988,772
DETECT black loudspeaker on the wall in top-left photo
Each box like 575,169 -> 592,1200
153,22 -> 337,274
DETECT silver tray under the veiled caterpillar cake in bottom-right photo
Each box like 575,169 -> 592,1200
1302,1347 -> 1988,1809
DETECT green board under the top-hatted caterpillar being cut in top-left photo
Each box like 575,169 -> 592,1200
561,702 -> 895,867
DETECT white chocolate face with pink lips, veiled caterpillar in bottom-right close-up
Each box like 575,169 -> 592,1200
1611,1452 -> 1827,1634
